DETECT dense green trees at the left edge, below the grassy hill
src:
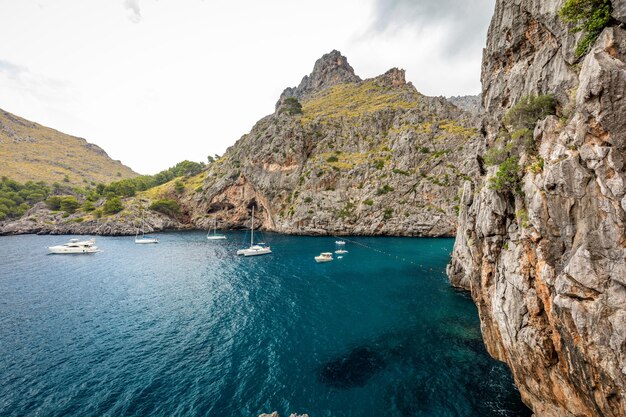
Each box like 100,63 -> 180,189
0,177 -> 50,221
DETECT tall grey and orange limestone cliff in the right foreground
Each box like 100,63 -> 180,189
448,0 -> 626,417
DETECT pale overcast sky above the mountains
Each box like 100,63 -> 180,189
0,0 -> 495,174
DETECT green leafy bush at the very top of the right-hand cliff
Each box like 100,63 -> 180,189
559,0 -> 613,57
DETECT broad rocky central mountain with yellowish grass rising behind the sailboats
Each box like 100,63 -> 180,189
190,51 -> 479,236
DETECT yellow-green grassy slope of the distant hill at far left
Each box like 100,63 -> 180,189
0,110 -> 137,185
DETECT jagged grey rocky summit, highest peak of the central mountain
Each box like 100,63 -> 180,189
277,50 -> 361,107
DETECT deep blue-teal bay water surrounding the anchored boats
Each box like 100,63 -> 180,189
0,232 -> 530,417
